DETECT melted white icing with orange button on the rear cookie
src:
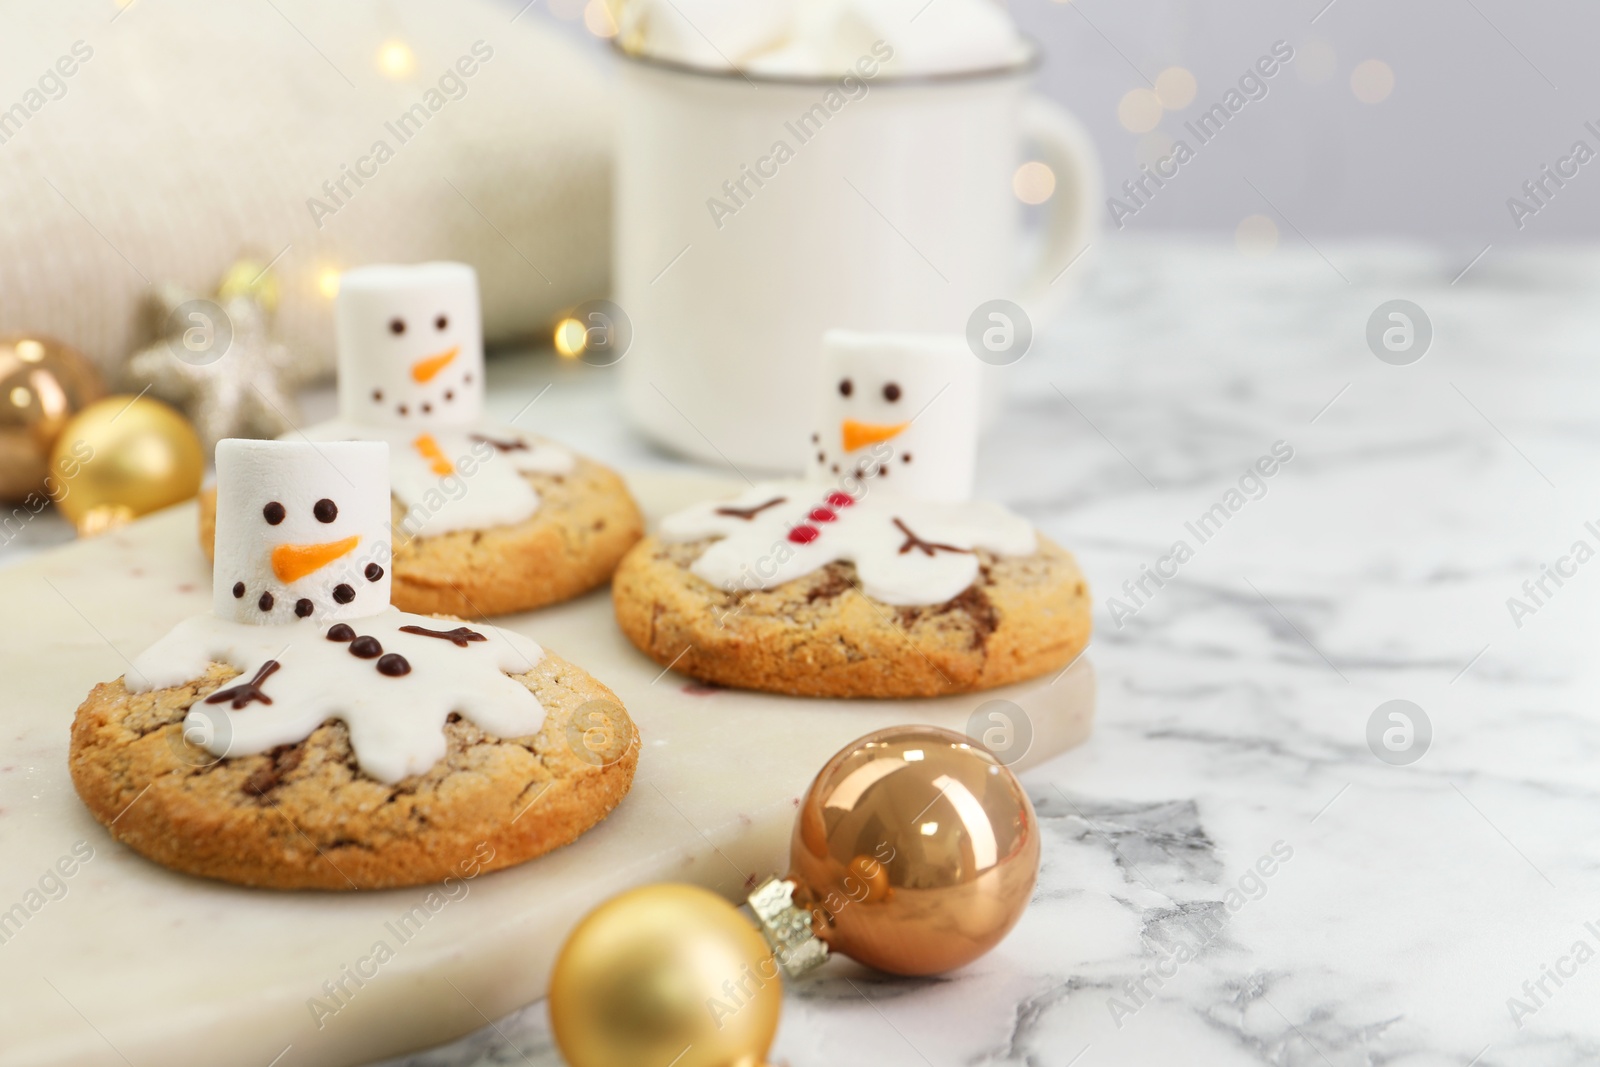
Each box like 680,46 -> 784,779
306,419 -> 576,536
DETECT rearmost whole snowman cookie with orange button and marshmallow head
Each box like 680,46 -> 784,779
190,262 -> 643,617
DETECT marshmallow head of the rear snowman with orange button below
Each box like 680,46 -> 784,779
334,262 -> 483,429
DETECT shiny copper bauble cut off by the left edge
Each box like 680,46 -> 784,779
0,334 -> 106,507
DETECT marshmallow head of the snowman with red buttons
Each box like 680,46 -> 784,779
808,330 -> 979,501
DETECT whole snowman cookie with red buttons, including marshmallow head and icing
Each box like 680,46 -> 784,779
611,334 -> 1090,697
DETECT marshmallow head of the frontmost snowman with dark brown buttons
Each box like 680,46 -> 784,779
211,438 -> 389,625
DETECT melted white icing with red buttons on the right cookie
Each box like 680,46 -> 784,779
659,482 -> 1038,606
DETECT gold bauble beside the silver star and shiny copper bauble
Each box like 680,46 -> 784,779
50,397 -> 205,534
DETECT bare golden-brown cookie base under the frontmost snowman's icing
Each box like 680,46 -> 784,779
70,652 -> 638,889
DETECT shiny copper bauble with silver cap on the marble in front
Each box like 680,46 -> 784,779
750,726 -> 1038,976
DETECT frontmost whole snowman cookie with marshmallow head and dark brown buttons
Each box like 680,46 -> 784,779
70,440 -> 638,889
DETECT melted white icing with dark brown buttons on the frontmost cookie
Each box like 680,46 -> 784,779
125,608 -> 544,784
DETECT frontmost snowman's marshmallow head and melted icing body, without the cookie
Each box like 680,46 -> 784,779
125,438 -> 544,784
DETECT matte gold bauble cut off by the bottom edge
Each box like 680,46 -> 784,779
550,885 -> 782,1067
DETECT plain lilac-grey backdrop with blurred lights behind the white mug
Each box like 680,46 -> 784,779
534,0 -> 1600,249
